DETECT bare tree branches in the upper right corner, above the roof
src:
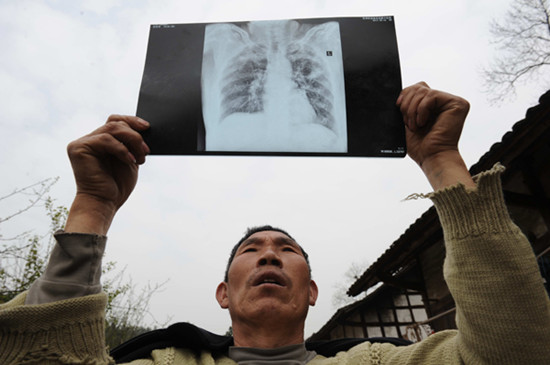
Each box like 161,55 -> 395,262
483,0 -> 550,103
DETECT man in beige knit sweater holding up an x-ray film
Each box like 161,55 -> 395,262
0,83 -> 550,365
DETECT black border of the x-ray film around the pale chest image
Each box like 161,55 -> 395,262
136,16 -> 406,157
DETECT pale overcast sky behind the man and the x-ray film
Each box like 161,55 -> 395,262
0,0 -> 544,336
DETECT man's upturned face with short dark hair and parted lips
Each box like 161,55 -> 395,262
216,231 -> 317,322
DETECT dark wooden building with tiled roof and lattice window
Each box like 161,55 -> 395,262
310,91 -> 550,341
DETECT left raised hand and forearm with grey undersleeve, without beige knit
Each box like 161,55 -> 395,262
21,115 -> 149,304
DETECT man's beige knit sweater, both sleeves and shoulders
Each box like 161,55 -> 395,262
0,166 -> 550,365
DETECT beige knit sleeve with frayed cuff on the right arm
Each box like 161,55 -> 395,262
381,165 -> 550,364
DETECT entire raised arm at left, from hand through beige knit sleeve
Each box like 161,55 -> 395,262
0,115 -> 149,364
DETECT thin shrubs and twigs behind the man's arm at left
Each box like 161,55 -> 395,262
0,178 -> 165,348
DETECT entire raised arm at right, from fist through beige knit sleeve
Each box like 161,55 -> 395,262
382,83 -> 550,364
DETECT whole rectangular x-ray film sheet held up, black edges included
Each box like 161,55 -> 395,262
137,16 -> 405,157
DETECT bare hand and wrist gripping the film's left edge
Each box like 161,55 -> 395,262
65,115 -> 150,235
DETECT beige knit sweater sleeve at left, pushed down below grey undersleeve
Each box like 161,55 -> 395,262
0,292 -> 114,365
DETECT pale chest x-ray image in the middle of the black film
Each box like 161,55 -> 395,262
201,20 -> 347,152
